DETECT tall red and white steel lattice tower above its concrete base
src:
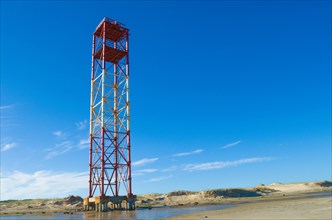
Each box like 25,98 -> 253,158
89,18 -> 133,197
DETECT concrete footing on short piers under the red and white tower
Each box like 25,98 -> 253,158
83,195 -> 137,212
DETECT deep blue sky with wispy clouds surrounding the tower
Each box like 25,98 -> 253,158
0,0 -> 332,200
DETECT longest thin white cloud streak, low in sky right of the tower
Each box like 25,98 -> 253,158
183,157 -> 272,171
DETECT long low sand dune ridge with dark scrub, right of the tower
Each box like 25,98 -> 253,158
137,181 -> 332,207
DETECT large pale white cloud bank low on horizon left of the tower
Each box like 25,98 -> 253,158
0,170 -> 88,200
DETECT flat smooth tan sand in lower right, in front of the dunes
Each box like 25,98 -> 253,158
170,195 -> 332,220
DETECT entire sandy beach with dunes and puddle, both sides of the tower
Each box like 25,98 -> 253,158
0,181 -> 332,220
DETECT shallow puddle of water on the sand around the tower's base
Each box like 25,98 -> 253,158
1,205 -> 234,220
